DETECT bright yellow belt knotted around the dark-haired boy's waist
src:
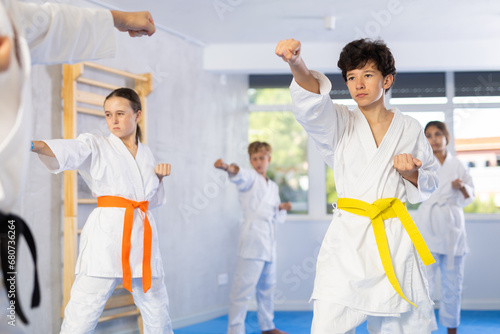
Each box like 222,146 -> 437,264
337,198 -> 436,307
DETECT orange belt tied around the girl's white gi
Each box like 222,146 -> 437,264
97,196 -> 153,293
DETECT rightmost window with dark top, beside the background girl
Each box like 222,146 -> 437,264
453,72 -> 500,213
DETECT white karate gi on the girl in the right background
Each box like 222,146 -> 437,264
416,152 -> 474,328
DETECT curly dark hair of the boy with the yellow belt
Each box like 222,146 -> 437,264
337,38 -> 396,93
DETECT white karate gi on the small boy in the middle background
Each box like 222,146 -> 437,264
228,168 -> 286,334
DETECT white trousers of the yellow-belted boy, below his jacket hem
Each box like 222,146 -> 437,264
311,299 -> 432,334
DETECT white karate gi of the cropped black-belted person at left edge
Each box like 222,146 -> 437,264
0,0 -> 116,333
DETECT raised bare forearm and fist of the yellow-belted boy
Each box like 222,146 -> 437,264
275,38 -> 319,94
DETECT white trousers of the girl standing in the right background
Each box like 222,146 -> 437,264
427,253 -> 465,328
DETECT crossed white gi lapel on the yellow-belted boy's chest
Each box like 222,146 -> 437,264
355,109 -> 404,193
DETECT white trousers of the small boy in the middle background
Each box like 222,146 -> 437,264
227,257 -> 276,334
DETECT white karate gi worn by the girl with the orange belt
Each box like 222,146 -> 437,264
39,134 -> 172,333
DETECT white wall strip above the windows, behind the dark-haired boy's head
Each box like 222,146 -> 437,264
204,39 -> 500,73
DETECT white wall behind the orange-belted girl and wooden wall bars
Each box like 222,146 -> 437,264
14,13 -> 248,333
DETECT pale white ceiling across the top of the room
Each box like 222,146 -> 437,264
94,0 -> 500,45
